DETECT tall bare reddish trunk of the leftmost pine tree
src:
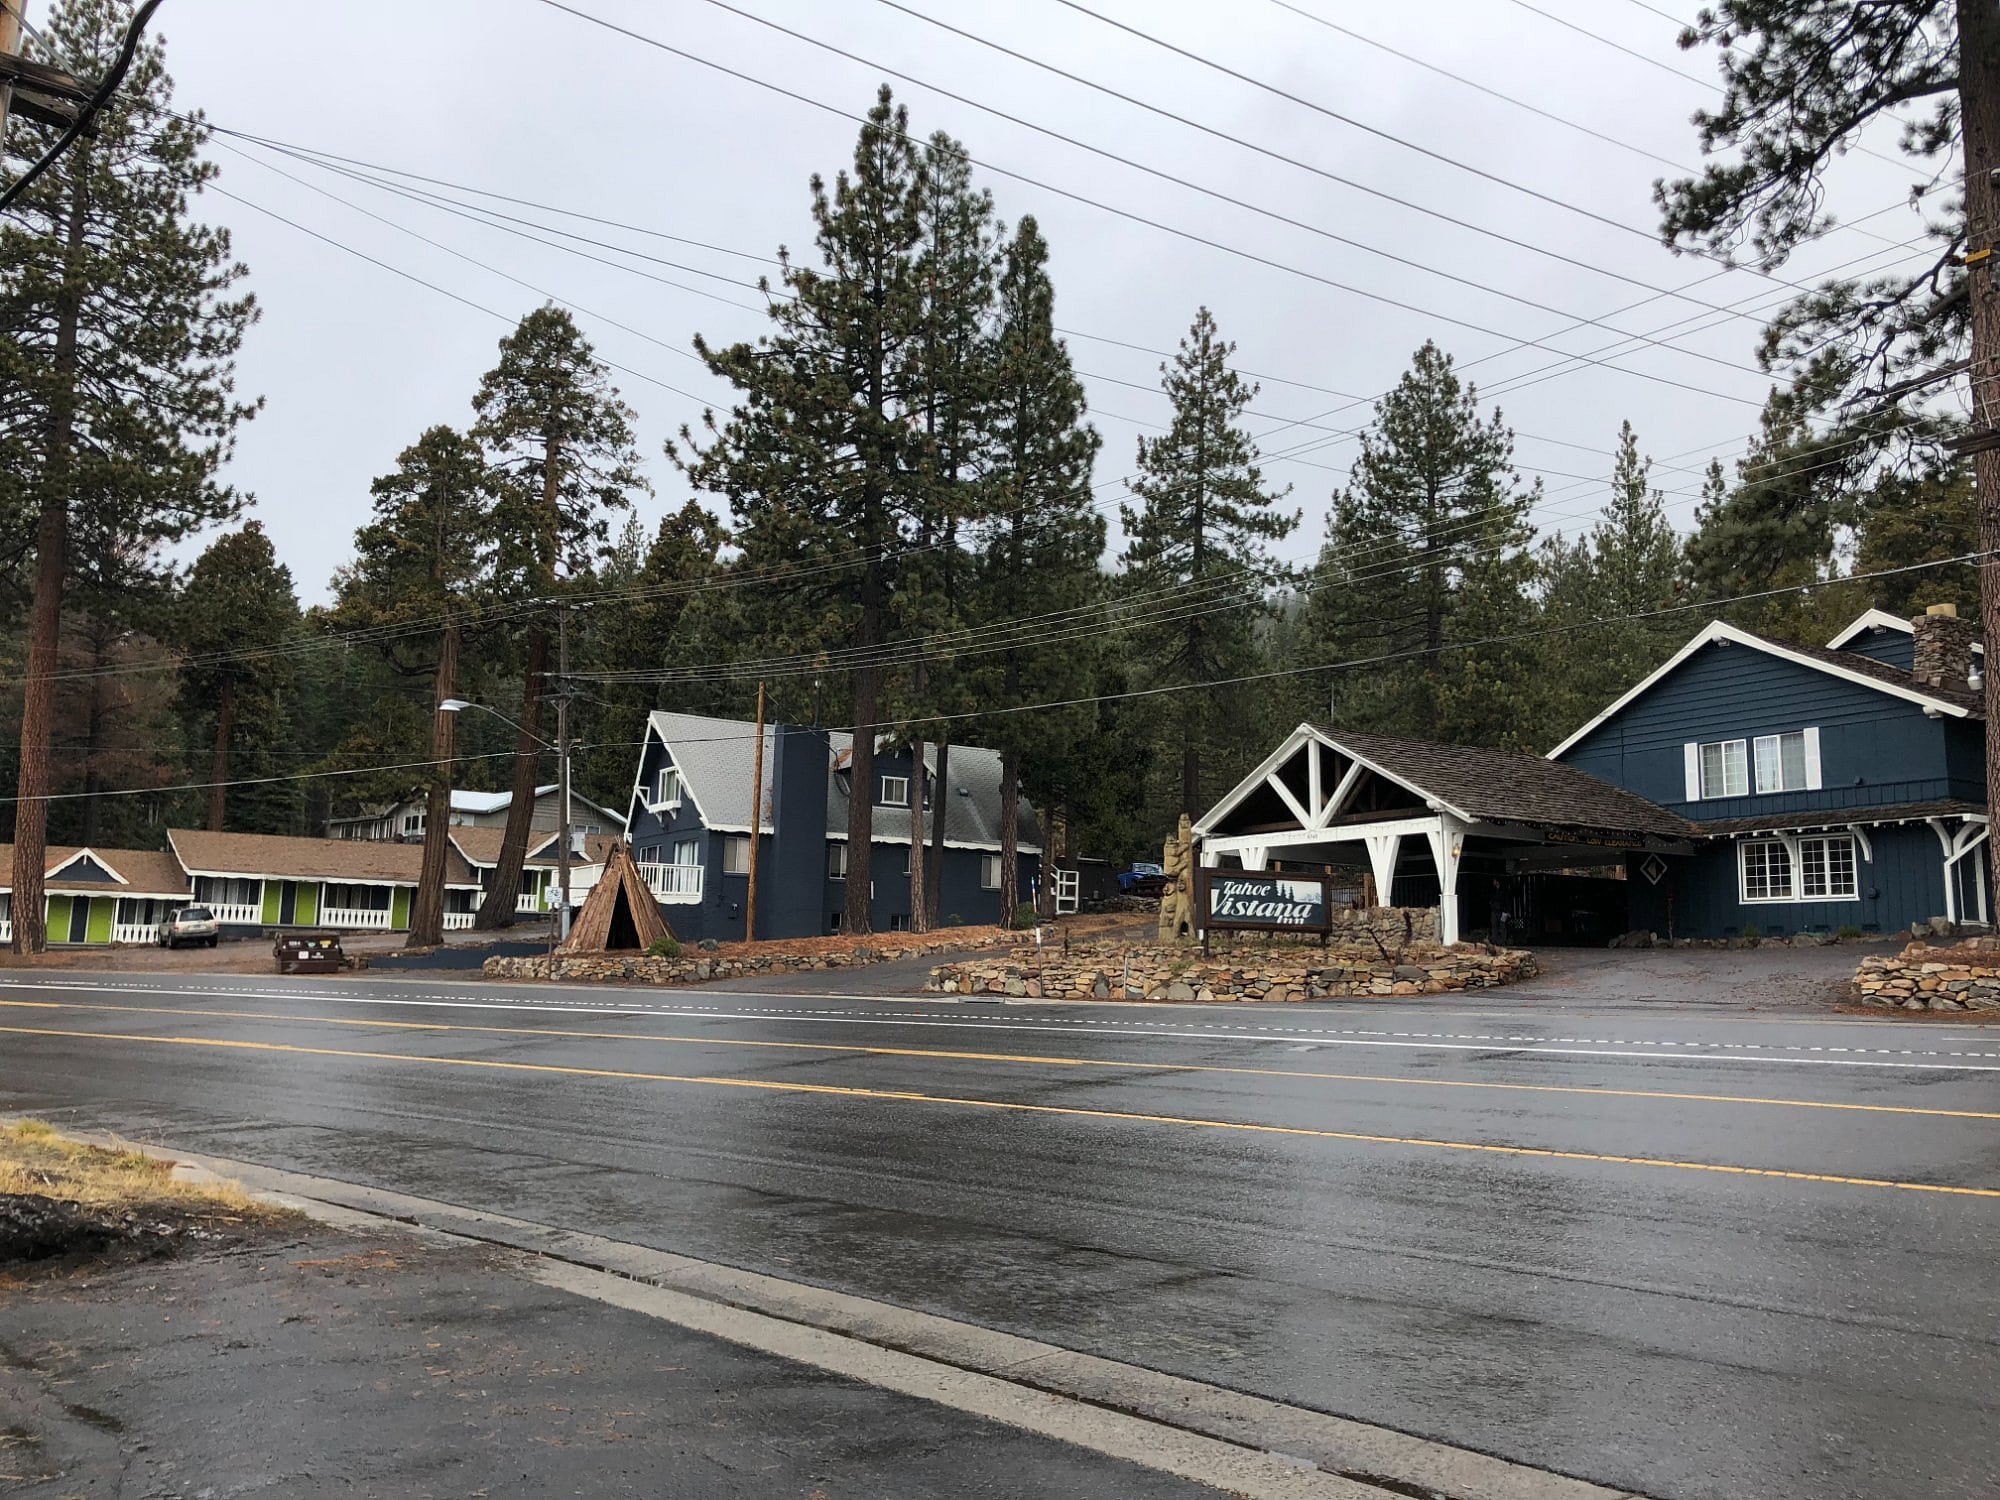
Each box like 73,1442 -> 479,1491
12,156 -> 90,954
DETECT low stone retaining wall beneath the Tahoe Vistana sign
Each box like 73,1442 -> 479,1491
928,944 -> 1536,1002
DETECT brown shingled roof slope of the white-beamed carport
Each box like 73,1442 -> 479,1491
1320,726 -> 1694,838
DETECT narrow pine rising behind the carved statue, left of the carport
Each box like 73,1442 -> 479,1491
1120,308 -> 1298,816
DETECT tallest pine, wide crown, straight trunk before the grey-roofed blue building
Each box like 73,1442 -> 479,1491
676,88 -> 936,932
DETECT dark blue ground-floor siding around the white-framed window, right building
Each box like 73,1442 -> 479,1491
1628,822 -> 1952,938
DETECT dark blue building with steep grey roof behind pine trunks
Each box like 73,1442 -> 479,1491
628,712 -> 1042,942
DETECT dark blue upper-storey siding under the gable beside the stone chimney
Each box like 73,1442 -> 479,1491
1562,644 -> 1970,820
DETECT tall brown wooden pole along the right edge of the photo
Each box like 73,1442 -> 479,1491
1946,0 -> 2000,916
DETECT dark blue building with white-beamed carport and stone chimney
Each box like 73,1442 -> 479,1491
1196,610 -> 1992,942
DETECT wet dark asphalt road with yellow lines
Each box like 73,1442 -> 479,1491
0,970 -> 2000,1500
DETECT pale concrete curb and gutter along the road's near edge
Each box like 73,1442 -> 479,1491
78,1134 -> 1644,1500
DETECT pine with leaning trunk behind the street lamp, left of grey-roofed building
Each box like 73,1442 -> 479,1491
472,302 -> 646,928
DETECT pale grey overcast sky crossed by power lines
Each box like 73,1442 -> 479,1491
113,0 -> 1920,602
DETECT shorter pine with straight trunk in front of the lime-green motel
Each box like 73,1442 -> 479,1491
330,426 -> 504,948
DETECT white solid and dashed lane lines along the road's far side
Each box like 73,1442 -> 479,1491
0,980 -> 2000,1072
